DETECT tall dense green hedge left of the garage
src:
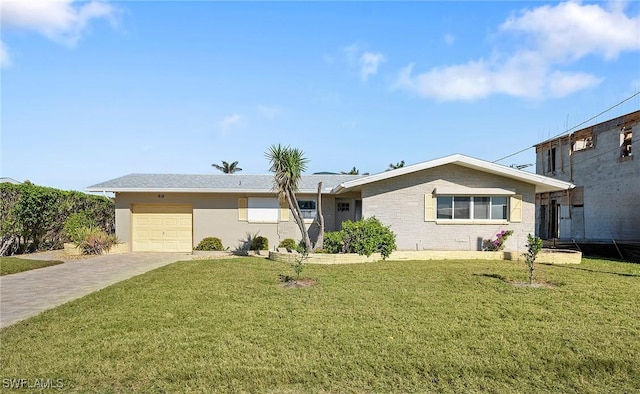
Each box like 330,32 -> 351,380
0,182 -> 115,256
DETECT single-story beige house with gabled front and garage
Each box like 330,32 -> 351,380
87,154 -> 573,252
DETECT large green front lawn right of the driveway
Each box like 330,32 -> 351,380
0,258 -> 640,393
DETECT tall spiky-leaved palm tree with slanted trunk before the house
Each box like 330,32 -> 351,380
265,144 -> 312,251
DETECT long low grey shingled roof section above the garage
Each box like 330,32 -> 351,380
87,174 -> 363,193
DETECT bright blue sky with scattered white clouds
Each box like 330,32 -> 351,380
0,0 -> 640,190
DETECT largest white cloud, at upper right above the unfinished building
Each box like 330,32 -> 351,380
393,2 -> 640,101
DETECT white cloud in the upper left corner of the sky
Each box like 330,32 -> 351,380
0,0 -> 119,67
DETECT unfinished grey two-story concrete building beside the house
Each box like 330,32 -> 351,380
535,111 -> 640,255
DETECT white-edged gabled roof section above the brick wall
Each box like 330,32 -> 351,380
332,154 -> 575,193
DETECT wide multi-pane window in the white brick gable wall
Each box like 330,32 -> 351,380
437,196 -> 508,220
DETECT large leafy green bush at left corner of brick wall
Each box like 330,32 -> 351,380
324,216 -> 396,259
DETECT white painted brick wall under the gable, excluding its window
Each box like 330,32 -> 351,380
362,164 -> 535,251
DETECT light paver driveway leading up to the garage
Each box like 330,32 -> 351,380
0,252 -> 193,328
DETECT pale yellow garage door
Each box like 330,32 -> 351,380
131,204 -> 193,252
